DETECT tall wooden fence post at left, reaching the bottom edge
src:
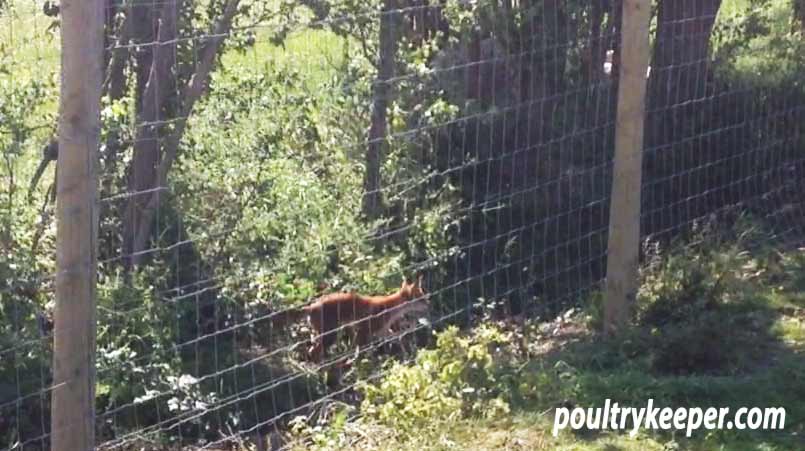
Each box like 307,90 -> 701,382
50,0 -> 104,451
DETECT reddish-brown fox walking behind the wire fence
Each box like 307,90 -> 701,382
302,276 -> 430,362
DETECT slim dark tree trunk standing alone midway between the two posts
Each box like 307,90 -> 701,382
363,0 -> 400,218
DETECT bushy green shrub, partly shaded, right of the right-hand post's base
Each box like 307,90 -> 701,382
636,223 -> 773,373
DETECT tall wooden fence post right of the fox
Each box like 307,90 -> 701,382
604,0 -> 651,334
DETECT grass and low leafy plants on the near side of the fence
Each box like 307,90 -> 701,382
282,224 -> 805,450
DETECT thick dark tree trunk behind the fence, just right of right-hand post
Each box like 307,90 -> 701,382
642,0 -> 724,237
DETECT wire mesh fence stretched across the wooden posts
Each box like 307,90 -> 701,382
0,0 -> 805,449
